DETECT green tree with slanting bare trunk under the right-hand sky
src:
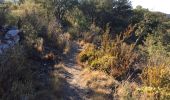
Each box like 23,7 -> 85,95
135,9 -> 166,45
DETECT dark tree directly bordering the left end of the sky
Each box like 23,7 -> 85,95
112,0 -> 133,32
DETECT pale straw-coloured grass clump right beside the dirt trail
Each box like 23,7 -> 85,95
80,69 -> 118,100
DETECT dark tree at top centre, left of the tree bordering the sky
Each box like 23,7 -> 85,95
80,0 -> 112,23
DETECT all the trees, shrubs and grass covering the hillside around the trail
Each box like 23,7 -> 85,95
0,0 -> 170,100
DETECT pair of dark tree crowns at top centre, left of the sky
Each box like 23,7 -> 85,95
80,0 -> 132,29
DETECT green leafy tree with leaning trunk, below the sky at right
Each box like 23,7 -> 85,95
132,6 -> 168,45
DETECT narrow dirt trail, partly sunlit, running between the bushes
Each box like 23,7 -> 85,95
55,42 -> 89,100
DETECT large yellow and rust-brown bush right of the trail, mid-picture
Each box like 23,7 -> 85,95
79,27 -> 138,77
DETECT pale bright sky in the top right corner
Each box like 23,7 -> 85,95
130,0 -> 170,14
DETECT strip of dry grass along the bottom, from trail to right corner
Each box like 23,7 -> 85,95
79,69 -> 169,100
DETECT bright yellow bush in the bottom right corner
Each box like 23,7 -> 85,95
140,64 -> 170,99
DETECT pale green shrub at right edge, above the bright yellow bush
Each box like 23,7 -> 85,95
140,35 -> 170,66
